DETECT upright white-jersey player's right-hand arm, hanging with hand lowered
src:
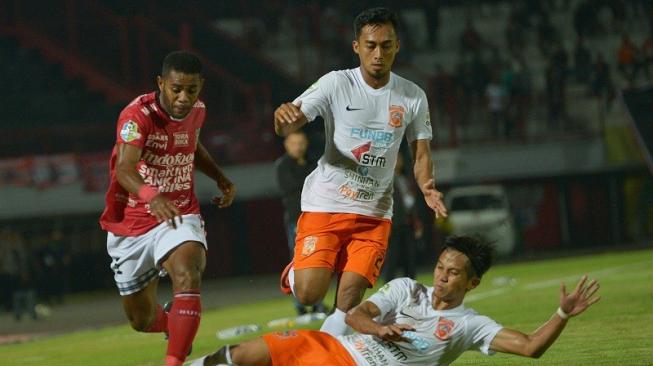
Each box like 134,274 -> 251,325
410,140 -> 447,217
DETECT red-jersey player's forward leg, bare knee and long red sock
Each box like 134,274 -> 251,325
163,241 -> 206,366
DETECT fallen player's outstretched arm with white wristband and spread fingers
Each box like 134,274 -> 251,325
490,275 -> 600,358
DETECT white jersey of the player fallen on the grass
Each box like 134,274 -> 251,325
337,278 -> 502,366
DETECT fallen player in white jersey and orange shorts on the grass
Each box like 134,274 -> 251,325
191,236 -> 600,366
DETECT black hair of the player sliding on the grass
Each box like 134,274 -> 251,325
442,235 -> 496,278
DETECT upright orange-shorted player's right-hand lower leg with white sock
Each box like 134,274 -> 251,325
320,272 -> 370,336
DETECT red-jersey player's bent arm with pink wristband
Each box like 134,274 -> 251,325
116,144 -> 181,228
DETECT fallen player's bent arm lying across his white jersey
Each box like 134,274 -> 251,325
345,301 -> 415,341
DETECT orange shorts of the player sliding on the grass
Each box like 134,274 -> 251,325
263,329 -> 356,366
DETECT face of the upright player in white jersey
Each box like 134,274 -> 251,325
353,23 -> 399,80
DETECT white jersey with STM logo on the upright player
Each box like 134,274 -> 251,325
293,68 -> 432,218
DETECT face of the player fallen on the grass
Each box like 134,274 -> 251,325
433,249 -> 479,304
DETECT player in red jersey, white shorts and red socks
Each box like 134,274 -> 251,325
100,51 -> 236,366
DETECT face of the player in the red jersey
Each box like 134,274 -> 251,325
157,70 -> 204,119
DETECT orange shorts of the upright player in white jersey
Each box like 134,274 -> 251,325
293,212 -> 392,286
